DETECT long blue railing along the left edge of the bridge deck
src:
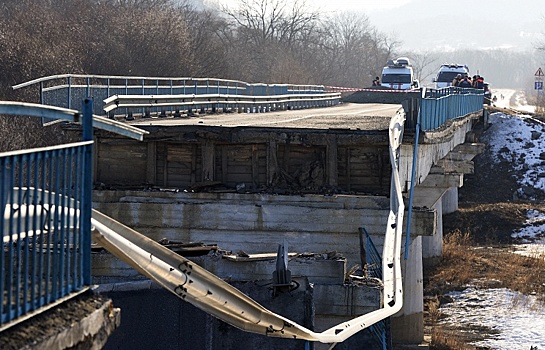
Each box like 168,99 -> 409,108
13,74 -> 340,119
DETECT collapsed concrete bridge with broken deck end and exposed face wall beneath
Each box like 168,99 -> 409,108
0,75 -> 482,346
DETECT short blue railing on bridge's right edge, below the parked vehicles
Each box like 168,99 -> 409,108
419,87 -> 484,131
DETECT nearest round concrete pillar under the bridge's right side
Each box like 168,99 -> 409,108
391,236 -> 424,344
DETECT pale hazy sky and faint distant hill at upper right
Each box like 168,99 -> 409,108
205,0 -> 545,52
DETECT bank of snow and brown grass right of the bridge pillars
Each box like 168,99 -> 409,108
424,108 -> 545,350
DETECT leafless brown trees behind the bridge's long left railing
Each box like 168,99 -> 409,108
0,0 -> 399,99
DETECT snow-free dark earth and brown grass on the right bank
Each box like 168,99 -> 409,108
424,110 -> 545,350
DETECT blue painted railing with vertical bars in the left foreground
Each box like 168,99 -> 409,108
0,100 -> 93,330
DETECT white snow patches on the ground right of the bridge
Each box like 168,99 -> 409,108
441,107 -> 545,350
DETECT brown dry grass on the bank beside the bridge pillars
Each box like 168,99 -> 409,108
425,230 -> 545,350
